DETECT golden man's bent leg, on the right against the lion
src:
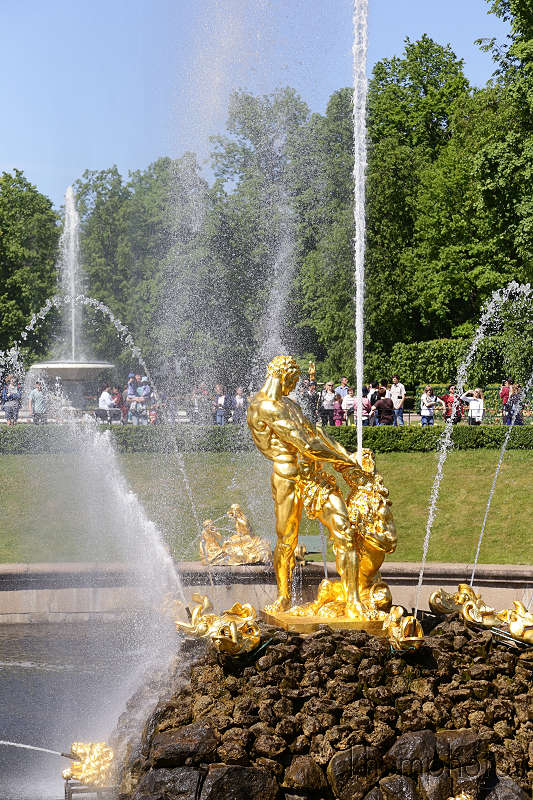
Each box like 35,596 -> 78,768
318,492 -> 361,611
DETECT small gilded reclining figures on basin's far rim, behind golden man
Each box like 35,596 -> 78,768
200,503 -> 272,566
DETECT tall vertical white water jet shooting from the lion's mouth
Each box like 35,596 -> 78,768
353,0 -> 368,463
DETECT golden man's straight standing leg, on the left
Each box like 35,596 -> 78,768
265,472 -> 302,613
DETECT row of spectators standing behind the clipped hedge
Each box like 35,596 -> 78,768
0,372 -> 524,427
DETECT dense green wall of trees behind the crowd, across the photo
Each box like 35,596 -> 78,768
0,0 -> 533,390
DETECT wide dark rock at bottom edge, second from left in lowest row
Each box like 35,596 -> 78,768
200,764 -> 278,800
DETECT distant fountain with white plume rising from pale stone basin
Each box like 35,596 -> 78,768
29,186 -> 113,408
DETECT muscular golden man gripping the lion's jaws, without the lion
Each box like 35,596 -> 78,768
248,356 -> 365,617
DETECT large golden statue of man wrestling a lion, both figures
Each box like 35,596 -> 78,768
248,356 -> 396,629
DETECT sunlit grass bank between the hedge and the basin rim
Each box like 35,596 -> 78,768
0,450 -> 533,564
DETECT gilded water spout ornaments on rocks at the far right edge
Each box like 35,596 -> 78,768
429,583 -> 533,644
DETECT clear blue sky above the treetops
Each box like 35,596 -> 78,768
0,0 -> 507,206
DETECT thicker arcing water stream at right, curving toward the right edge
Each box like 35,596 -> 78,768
415,281 -> 531,615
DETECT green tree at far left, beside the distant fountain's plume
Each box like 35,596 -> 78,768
0,169 -> 59,357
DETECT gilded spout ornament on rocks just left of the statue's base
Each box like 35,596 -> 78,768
176,593 -> 261,656
